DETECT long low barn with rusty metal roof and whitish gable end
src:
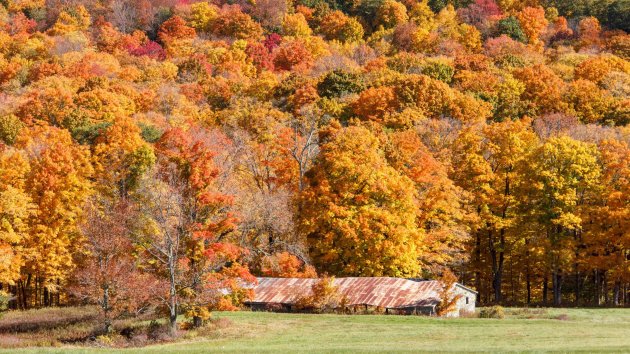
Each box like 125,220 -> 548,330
246,277 -> 477,316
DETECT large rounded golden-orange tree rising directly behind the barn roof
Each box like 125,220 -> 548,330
299,123 -> 422,277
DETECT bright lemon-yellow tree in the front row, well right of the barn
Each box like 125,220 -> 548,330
522,136 -> 600,306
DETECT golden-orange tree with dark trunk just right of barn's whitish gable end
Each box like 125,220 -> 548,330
454,120 -> 537,302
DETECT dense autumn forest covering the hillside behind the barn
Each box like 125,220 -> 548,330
0,0 -> 630,338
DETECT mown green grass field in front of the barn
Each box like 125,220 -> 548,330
0,309 -> 630,353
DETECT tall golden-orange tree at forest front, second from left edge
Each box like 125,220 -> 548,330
16,126 -> 93,304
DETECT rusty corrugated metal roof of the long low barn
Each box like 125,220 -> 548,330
251,277 -> 450,308
